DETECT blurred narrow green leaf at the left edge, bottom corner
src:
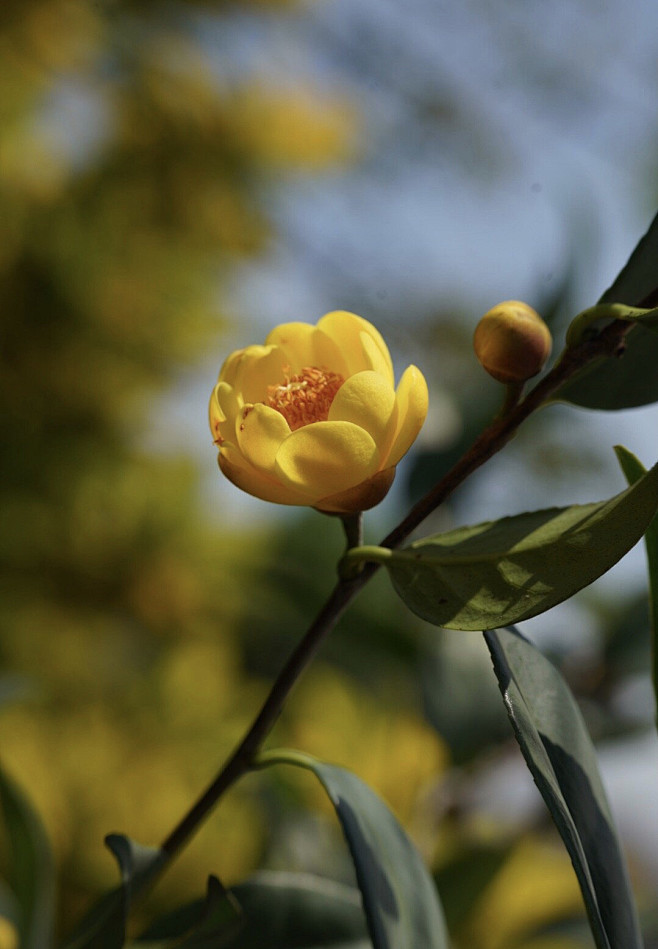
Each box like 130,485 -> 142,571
0,770 -> 55,949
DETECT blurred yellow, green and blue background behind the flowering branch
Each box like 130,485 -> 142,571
0,0 -> 658,949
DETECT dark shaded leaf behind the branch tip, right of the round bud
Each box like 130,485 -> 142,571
554,215 -> 658,410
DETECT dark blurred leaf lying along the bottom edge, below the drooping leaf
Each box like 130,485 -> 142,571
135,872 -> 364,949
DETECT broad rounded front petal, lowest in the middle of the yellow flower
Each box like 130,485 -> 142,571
276,422 -> 379,503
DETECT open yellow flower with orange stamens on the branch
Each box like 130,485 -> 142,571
210,310 -> 427,514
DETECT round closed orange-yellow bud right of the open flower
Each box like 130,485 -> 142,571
473,300 -> 552,384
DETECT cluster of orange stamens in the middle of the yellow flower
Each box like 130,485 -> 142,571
266,366 -> 345,431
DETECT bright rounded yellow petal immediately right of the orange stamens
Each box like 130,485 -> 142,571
329,370 -> 395,451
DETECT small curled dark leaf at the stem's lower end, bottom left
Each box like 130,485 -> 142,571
63,834 -> 167,949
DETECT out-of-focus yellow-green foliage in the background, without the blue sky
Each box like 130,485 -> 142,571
0,0 -> 652,949
